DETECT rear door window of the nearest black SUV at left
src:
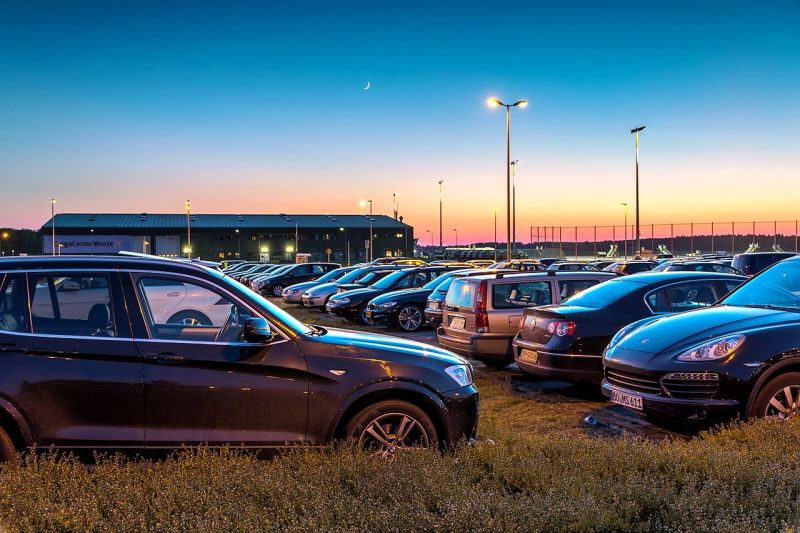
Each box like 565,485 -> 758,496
30,274 -> 117,337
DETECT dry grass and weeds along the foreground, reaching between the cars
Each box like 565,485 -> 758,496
0,302 -> 800,531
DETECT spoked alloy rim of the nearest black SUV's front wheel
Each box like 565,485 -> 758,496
358,413 -> 430,456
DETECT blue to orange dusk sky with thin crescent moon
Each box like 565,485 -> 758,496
0,0 -> 800,243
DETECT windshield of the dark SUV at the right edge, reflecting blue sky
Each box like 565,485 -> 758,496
721,261 -> 800,311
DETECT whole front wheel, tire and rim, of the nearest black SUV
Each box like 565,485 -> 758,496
345,400 -> 439,455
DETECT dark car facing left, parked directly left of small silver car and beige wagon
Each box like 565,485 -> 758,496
366,264 -> 473,331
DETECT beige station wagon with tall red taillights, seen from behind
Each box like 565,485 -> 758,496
437,271 -> 614,368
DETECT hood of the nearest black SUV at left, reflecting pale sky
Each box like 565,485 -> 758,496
314,328 -> 468,365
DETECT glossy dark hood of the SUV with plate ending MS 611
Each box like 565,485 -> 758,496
617,305 -> 800,354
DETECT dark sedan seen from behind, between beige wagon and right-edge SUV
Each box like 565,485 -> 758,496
513,272 -> 746,384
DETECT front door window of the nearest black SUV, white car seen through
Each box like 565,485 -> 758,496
136,276 -> 250,342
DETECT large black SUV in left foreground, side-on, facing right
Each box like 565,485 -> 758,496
0,256 -> 478,460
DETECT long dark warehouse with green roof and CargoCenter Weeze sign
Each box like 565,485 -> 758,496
41,213 -> 414,264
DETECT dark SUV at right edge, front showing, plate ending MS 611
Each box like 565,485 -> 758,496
602,258 -> 800,424
